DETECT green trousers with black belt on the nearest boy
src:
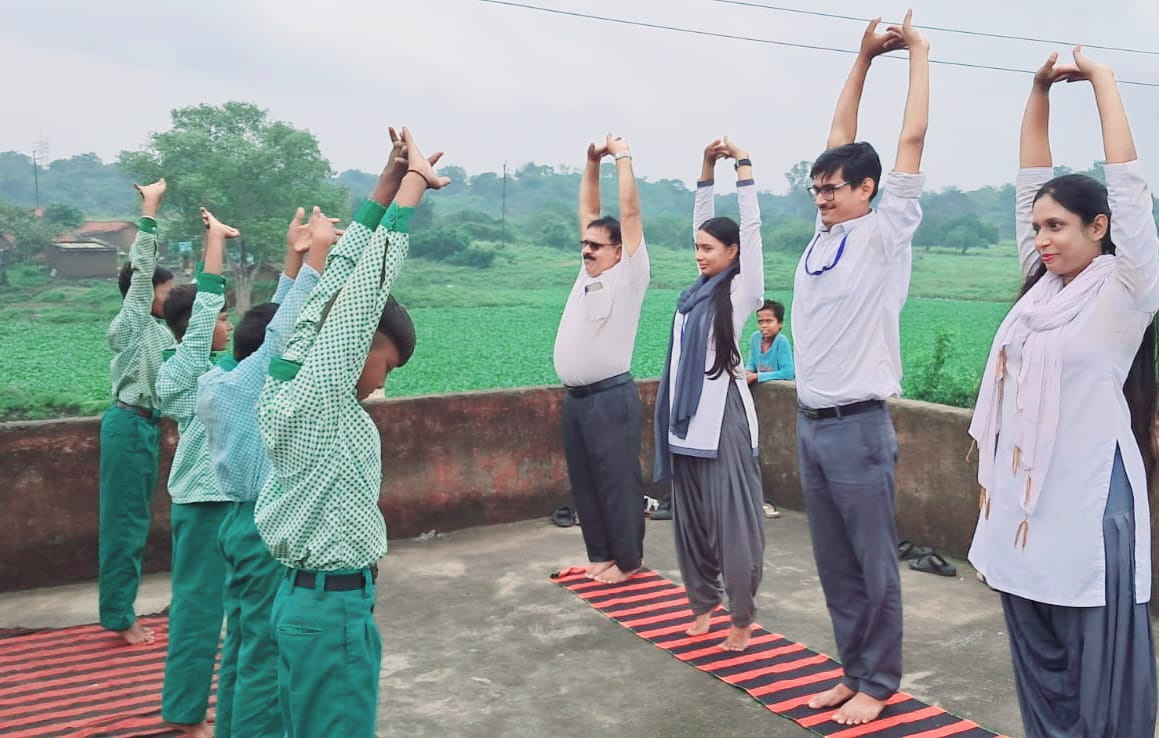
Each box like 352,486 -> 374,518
274,569 -> 382,738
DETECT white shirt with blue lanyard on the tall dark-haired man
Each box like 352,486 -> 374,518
793,171 -> 926,408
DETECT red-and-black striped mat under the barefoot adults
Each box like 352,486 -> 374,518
552,568 -> 997,738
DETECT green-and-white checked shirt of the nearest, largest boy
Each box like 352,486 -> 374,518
254,202 -> 414,571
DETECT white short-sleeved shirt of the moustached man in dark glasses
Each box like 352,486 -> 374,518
553,236 -> 651,387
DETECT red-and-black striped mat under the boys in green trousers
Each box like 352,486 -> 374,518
0,615 -> 200,738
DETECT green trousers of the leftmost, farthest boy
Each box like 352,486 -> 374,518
97,405 -> 161,630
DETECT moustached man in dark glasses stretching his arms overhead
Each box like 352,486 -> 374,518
554,133 -> 650,584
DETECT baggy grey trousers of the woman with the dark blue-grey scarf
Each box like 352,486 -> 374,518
672,385 -> 765,628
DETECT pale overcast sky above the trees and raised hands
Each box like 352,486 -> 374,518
0,0 -> 1159,191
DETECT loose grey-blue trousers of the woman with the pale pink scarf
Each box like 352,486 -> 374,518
1003,448 -> 1157,738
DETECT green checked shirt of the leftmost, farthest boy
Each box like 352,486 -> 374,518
107,215 -> 174,408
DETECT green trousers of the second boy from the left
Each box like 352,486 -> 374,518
161,502 -> 231,724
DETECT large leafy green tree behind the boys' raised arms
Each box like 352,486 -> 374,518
119,102 -> 349,312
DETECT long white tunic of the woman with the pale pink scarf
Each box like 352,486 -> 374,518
969,161 -> 1159,607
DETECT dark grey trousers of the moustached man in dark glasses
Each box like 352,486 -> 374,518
563,375 -> 644,572
